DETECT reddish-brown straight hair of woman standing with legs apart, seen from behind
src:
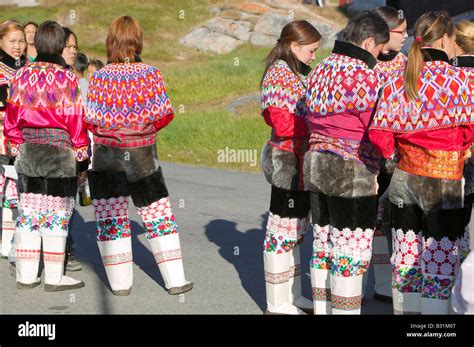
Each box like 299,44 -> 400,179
105,16 -> 143,63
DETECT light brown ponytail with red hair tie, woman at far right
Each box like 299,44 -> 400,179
404,11 -> 454,101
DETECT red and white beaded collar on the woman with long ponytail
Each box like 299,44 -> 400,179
371,61 -> 472,133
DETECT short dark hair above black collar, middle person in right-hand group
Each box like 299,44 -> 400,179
341,11 -> 390,45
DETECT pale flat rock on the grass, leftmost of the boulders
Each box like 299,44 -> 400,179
179,27 -> 243,54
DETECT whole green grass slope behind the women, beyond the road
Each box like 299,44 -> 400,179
0,0 -> 329,172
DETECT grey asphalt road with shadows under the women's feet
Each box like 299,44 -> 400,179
0,163 -> 464,314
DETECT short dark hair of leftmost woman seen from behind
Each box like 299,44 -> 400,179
35,20 -> 66,54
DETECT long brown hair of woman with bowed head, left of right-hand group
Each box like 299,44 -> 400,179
260,20 -> 321,84
